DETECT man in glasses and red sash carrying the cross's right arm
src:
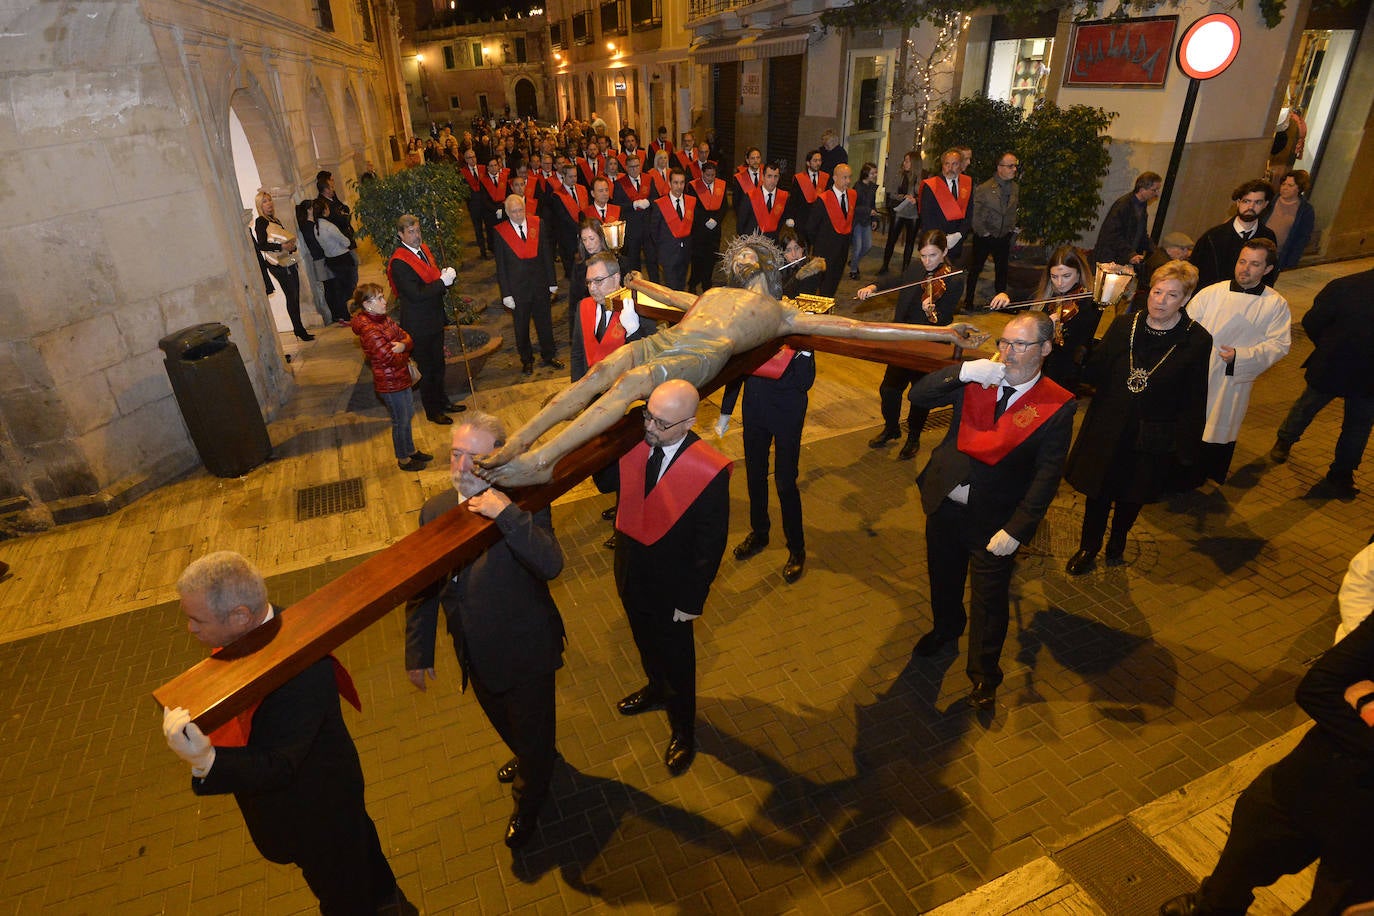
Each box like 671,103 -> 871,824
911,312 -> 1074,711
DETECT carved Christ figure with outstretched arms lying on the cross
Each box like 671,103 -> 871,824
477,235 -> 988,486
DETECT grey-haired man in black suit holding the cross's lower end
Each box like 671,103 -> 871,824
162,551 -> 416,913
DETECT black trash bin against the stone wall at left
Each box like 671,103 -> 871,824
158,321 -> 272,477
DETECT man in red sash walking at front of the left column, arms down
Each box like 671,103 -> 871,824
496,195 -> 566,375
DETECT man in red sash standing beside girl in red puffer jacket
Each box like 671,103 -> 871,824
386,213 -> 463,426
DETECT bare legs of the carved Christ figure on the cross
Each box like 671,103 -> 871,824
475,343 -> 654,486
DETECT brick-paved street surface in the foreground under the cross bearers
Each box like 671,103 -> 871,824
0,254 -> 1371,915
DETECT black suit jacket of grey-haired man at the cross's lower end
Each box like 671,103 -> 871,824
191,612 -> 367,862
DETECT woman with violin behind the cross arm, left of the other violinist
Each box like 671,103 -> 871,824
856,229 -> 963,460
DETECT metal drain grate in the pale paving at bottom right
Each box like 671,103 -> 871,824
1051,821 -> 1198,916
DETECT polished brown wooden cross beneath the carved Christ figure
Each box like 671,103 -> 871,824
153,325 -> 955,732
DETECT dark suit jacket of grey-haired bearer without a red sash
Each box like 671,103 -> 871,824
405,490 -> 563,694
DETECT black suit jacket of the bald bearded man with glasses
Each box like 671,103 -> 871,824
616,433 -> 730,618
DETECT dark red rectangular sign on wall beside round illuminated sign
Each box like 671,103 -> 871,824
1063,16 -> 1179,89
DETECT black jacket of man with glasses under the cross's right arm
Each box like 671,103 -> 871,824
910,365 -> 1077,544
